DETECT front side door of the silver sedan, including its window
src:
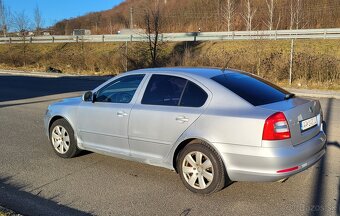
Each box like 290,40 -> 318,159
78,74 -> 144,155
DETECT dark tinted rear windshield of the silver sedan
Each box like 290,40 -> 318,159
211,73 -> 289,106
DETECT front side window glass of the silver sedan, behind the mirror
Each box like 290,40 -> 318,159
96,74 -> 144,103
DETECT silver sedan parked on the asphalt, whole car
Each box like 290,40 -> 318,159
45,68 -> 326,194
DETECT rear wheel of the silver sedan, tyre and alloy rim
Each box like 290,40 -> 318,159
177,141 -> 231,194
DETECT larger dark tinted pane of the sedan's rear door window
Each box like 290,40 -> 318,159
142,75 -> 187,106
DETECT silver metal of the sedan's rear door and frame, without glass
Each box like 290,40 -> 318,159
129,72 -> 212,162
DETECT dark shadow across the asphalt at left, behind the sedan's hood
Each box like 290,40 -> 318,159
0,75 -> 110,102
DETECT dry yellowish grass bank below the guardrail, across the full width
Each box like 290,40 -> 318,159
0,40 -> 340,90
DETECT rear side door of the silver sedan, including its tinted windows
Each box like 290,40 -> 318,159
129,74 -> 209,161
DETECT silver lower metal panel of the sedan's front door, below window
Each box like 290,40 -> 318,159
77,102 -> 132,155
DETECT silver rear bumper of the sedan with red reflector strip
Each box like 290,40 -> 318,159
214,131 -> 326,181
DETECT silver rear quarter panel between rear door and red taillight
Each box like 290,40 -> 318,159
165,106 -> 272,169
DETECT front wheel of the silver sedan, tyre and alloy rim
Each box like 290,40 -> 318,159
50,119 -> 80,158
